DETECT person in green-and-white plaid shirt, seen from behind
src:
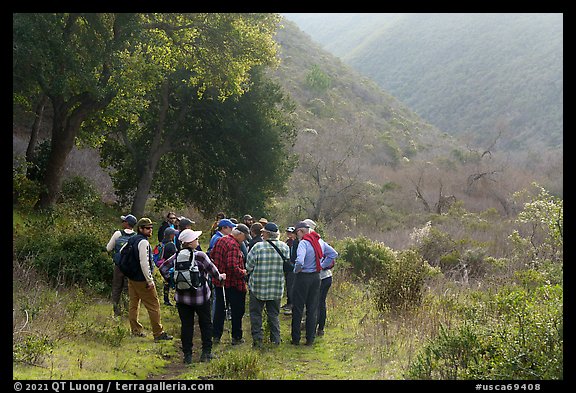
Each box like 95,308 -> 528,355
246,222 -> 290,348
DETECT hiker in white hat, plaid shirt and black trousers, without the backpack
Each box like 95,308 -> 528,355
174,229 -> 226,364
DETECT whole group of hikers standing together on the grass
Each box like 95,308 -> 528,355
106,212 -> 338,364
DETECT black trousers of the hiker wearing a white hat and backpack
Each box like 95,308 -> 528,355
176,300 -> 212,355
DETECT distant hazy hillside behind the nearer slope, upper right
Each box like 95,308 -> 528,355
285,13 -> 563,150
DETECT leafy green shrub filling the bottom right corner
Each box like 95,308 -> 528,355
407,285 -> 563,380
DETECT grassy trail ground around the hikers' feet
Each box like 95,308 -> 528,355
13,274 -> 401,380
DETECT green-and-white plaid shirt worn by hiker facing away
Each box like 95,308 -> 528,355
246,240 -> 290,300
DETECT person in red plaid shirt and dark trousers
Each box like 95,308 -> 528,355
210,224 -> 250,345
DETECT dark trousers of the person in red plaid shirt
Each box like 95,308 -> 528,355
214,287 -> 246,340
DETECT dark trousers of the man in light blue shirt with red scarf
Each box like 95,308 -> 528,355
292,272 -> 320,343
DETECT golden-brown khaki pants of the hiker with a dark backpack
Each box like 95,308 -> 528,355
128,279 -> 164,337
